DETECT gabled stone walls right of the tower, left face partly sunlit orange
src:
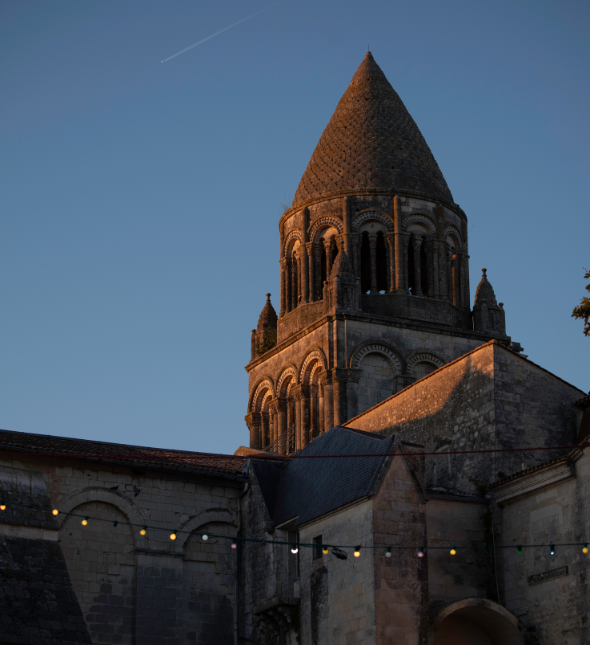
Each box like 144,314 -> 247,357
345,342 -> 580,496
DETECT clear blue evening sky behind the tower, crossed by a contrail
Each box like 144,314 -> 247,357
0,0 -> 590,452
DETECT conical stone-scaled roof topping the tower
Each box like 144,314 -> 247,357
293,52 -> 453,206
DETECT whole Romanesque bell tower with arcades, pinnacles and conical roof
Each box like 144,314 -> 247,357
246,53 -> 510,453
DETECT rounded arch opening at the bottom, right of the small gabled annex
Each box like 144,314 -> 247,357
432,598 -> 524,645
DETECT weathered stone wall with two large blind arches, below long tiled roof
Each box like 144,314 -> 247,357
0,457 -> 243,645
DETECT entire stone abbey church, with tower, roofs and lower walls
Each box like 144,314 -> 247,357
0,53 -> 590,645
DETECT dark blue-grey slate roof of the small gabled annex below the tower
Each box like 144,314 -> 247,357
252,427 -> 394,526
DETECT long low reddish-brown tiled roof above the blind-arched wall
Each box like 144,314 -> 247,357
0,430 -> 246,479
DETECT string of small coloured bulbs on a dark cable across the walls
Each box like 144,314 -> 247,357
0,500 -> 590,560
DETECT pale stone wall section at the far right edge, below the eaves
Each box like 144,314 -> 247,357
495,449 -> 590,645
